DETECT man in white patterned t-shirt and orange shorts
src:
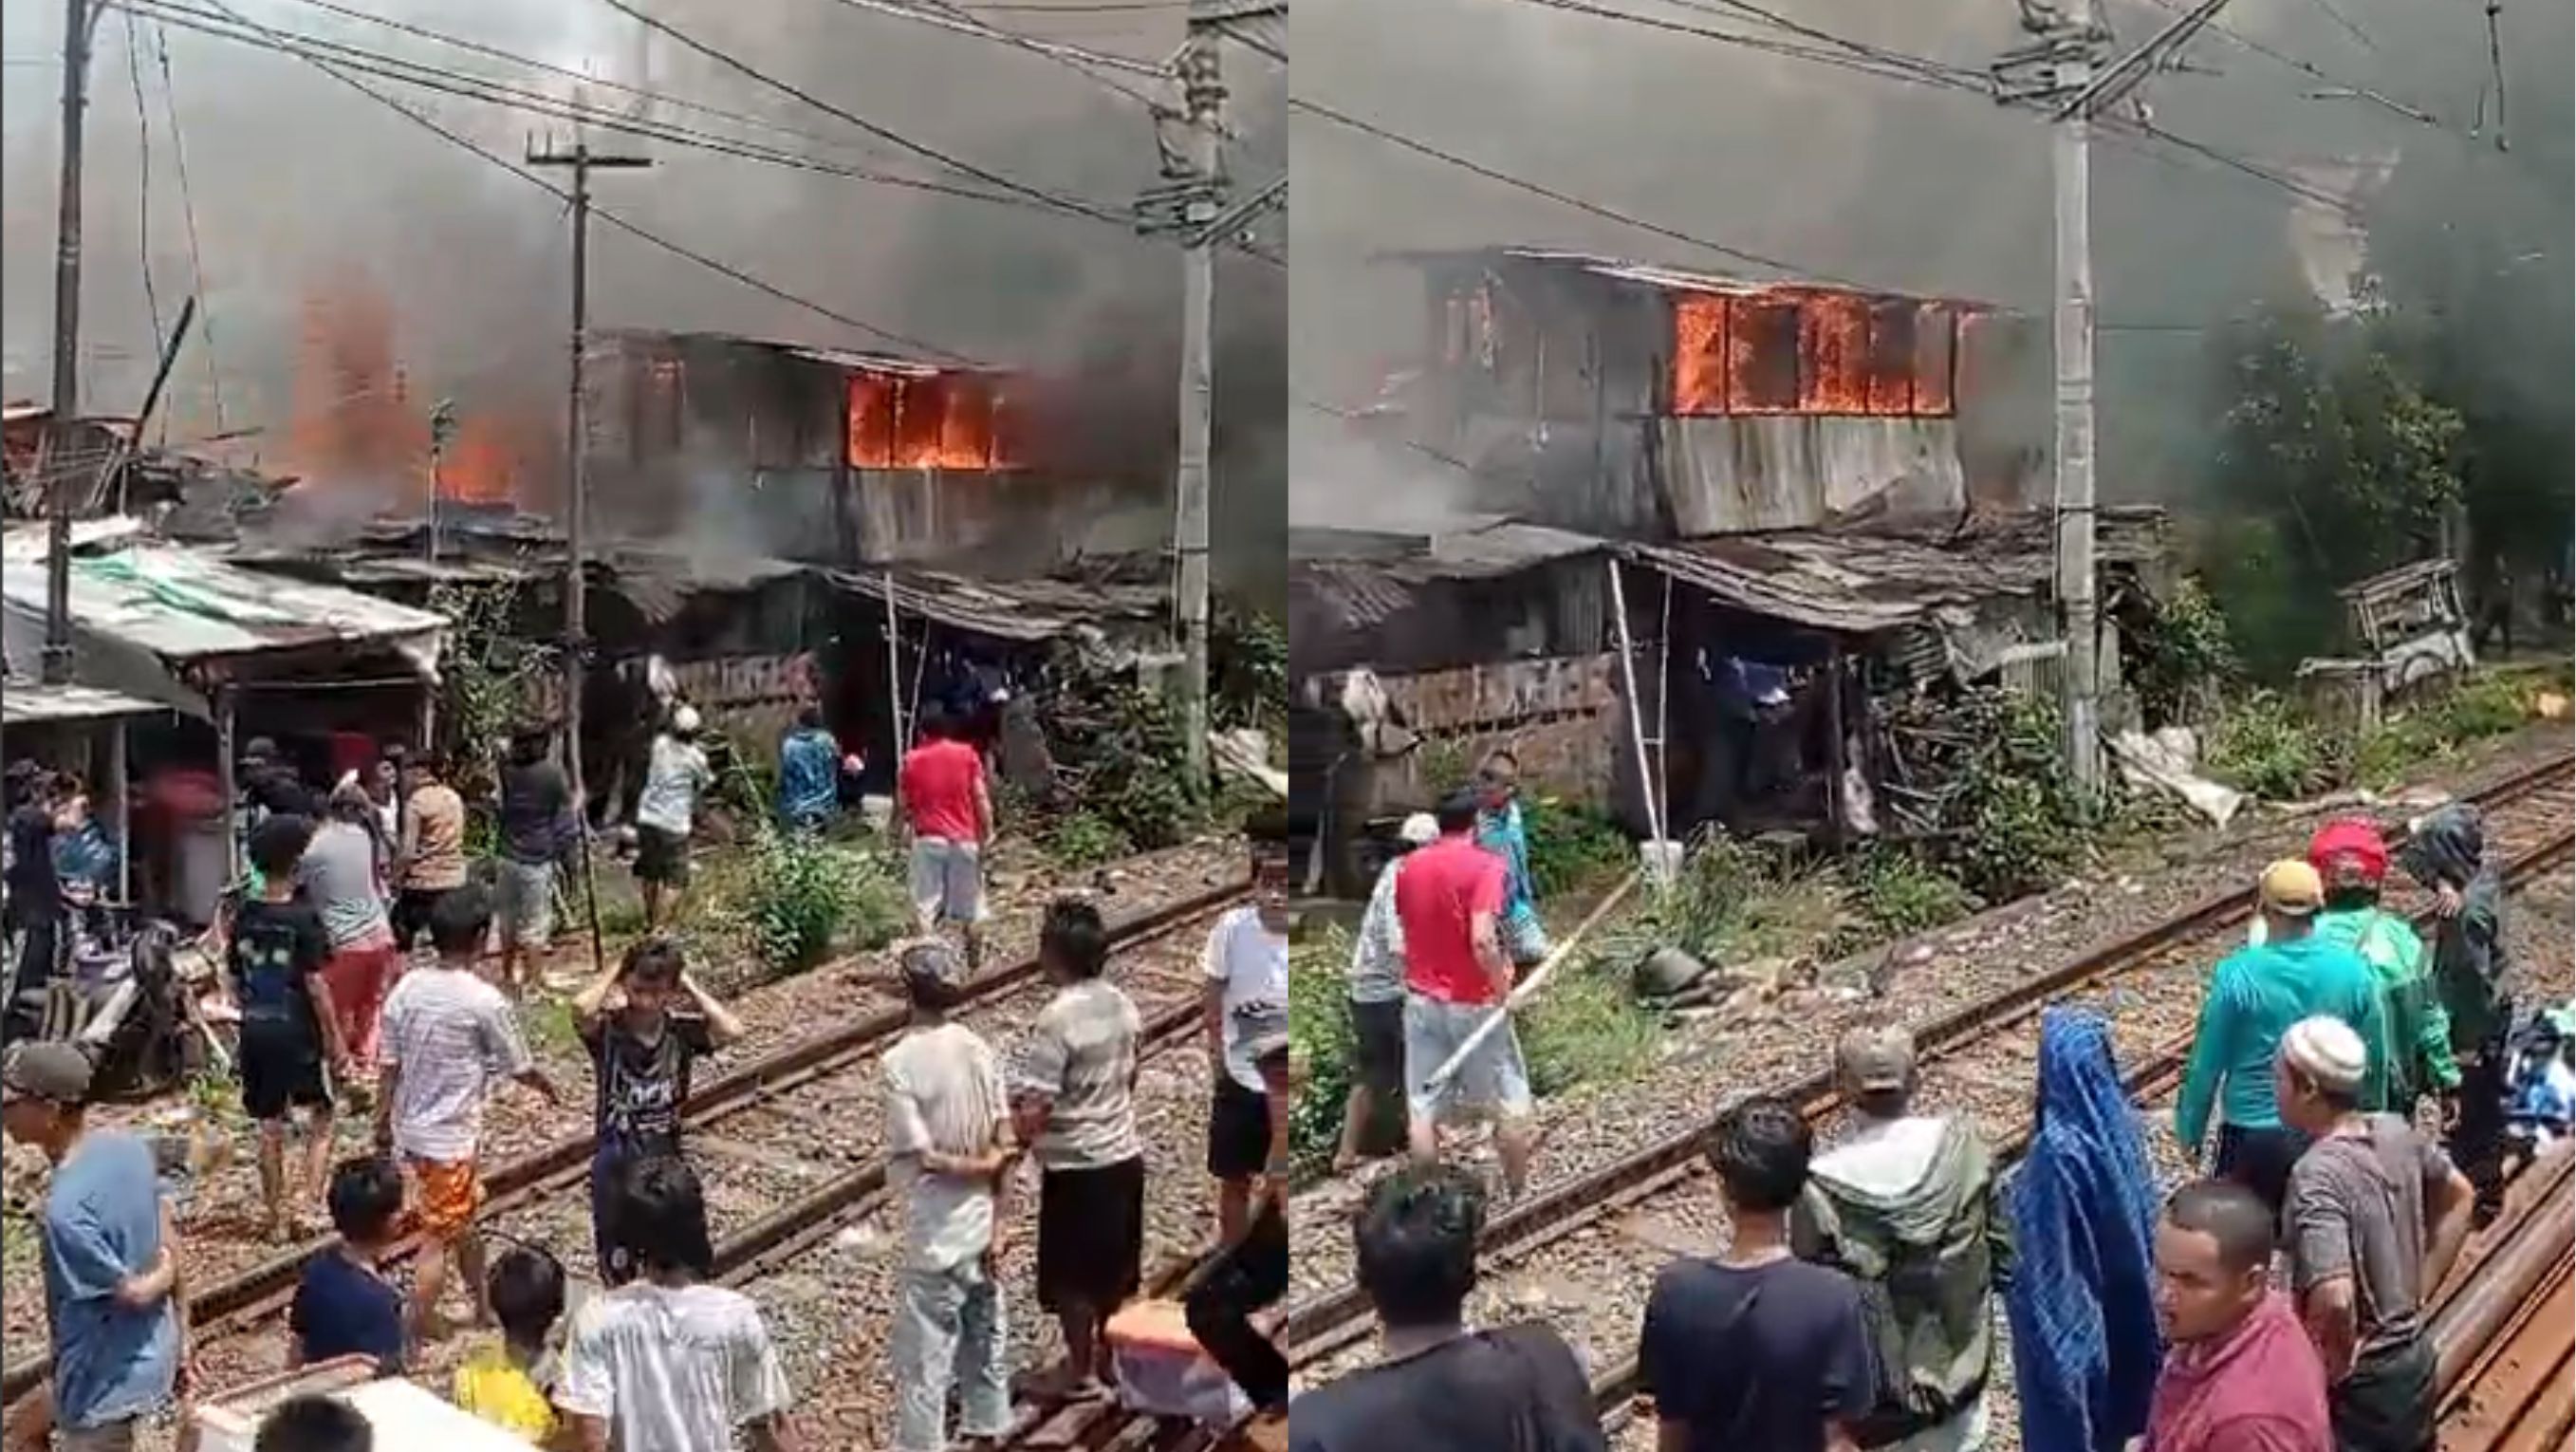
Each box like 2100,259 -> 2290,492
376,885 -> 559,1341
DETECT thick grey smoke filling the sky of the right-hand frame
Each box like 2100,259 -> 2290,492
1290,0 -> 2571,523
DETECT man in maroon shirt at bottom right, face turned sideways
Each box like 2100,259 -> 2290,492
2130,1179 -> 2334,1452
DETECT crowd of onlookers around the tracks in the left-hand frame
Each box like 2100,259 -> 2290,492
5,684 -> 1296,1452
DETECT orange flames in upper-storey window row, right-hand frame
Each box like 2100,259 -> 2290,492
1672,289 -> 1963,417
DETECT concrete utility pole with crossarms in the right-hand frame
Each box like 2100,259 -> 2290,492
1993,0 -> 2228,798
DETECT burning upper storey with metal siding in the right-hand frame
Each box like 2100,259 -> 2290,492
1386,247 -> 2048,538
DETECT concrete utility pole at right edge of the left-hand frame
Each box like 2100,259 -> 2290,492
1172,16 -> 1226,788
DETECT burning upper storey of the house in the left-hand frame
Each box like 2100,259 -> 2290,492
592,332 -> 1161,577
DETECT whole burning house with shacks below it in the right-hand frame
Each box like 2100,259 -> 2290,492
1290,250 -> 2164,888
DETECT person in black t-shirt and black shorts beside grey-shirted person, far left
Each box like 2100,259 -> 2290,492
224,813 -> 348,1241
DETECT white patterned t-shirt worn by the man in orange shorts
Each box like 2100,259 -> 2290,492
384,963 -> 533,1163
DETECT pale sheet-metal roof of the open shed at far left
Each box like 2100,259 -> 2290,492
0,520 -> 448,672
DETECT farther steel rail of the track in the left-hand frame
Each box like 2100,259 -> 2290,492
0,878 -> 1251,1405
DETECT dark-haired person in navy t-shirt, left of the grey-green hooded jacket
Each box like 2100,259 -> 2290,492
1636,1097 -> 1878,1452
